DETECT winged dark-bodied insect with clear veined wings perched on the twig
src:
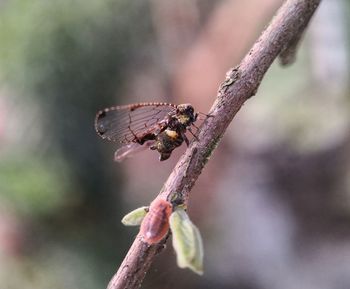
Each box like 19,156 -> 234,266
95,102 -> 198,161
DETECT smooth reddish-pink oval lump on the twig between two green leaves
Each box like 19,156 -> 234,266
140,198 -> 173,245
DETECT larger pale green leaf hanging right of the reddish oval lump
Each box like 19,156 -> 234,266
169,208 -> 203,275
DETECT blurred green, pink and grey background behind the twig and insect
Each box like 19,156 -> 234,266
0,0 -> 350,289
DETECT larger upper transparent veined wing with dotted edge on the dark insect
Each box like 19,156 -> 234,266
95,103 -> 176,144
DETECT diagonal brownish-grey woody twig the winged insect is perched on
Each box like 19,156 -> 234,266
108,0 -> 321,289
